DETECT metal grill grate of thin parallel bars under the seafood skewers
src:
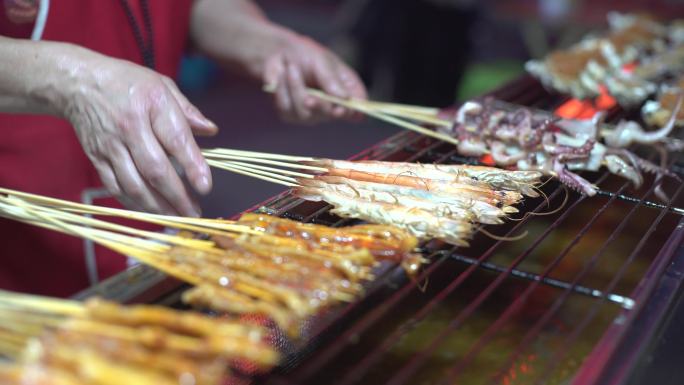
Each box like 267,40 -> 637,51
255,78 -> 683,385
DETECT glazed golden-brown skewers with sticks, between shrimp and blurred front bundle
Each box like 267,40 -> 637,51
0,189 -> 423,337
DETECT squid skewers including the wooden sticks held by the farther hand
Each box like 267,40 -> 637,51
260,82 -> 684,200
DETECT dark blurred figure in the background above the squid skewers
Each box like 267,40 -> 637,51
343,0 -> 480,107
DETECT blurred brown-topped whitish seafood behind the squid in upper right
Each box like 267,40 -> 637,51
525,12 -> 669,100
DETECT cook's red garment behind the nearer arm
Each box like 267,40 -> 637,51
0,0 -> 192,296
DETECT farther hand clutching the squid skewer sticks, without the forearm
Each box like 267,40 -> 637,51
263,30 -> 367,123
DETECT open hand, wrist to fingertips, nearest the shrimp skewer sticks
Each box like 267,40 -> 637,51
58,49 -> 217,216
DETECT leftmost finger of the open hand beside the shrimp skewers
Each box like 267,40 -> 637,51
109,141 -> 176,214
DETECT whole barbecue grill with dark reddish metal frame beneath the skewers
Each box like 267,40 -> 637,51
72,76 -> 684,385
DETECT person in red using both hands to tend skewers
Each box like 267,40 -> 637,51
0,0 -> 365,296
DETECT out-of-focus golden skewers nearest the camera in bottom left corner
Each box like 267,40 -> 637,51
0,292 -> 279,385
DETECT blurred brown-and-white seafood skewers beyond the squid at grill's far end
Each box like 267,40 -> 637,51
525,12 -> 684,106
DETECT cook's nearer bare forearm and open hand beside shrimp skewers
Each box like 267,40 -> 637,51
0,37 -> 216,216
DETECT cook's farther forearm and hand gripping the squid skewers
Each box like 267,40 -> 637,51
190,0 -> 366,121
